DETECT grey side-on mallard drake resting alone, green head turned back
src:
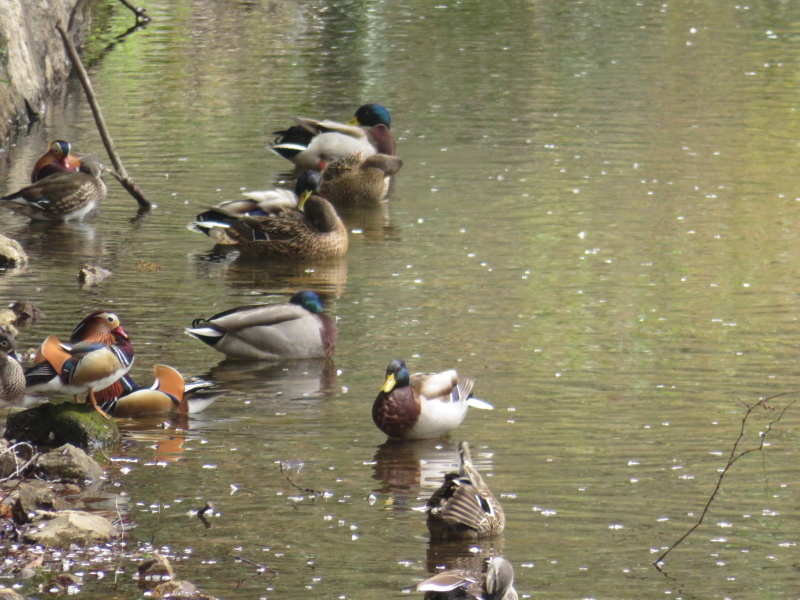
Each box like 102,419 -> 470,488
186,290 -> 339,360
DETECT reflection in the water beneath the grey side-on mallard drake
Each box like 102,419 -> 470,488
203,359 -> 337,400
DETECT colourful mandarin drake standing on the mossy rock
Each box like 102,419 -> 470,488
25,325 -> 133,418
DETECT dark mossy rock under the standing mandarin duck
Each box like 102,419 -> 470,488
3,402 -> 119,452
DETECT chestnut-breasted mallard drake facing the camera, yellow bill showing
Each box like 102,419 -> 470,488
372,358 -> 492,440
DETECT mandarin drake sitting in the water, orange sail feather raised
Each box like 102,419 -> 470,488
100,365 -> 216,418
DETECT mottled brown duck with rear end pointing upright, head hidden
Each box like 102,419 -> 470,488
425,442 -> 506,540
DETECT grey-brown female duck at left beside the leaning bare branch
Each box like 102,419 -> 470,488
0,161 -> 106,221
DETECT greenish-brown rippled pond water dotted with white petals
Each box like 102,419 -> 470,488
0,0 -> 800,599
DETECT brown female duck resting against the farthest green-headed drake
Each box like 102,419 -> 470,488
319,144 -> 403,208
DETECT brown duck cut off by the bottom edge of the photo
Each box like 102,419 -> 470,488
417,556 -> 518,600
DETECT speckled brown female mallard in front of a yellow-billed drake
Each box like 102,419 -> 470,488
194,171 -> 347,260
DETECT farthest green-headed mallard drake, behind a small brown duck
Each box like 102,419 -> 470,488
272,104 -> 394,169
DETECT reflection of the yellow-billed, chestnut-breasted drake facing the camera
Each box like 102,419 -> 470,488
372,440 -> 458,496
